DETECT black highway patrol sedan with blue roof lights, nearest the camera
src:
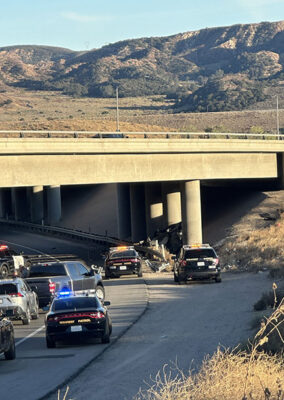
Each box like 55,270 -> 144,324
45,296 -> 112,348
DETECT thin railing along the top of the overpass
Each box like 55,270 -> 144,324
0,130 -> 284,140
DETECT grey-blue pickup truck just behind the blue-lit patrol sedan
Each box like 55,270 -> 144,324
25,260 -> 105,308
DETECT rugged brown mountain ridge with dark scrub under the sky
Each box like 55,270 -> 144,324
0,21 -> 284,111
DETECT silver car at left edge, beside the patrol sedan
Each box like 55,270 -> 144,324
0,278 -> 39,325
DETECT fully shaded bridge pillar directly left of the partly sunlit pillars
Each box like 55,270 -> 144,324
130,183 -> 146,242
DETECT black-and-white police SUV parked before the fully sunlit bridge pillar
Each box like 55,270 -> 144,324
174,244 -> 222,283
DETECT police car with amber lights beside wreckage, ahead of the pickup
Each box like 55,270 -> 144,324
104,246 -> 143,279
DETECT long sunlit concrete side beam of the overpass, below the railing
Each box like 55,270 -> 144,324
0,153 -> 278,187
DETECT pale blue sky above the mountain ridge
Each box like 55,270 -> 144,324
0,0 -> 284,50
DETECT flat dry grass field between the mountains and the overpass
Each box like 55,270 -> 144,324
0,88 -> 284,132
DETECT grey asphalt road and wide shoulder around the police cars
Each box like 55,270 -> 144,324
0,231 -> 272,400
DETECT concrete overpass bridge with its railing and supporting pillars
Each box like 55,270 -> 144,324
0,131 -> 284,243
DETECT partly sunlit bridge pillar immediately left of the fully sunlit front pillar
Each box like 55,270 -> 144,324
162,182 -> 181,227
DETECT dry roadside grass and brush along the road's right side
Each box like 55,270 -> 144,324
135,210 -> 284,400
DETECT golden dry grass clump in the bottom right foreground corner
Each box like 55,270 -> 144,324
136,349 -> 284,400
